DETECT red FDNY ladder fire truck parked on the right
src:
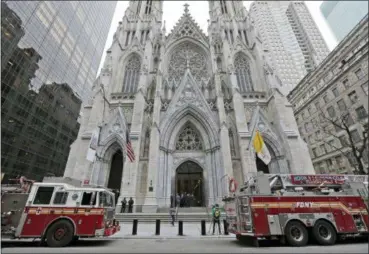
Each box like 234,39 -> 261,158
223,173 -> 369,246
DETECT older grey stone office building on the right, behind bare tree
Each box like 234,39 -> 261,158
288,16 -> 368,174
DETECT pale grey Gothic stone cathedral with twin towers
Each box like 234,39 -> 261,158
65,1 -> 313,212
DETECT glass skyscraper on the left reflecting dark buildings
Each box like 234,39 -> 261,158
1,1 -> 117,180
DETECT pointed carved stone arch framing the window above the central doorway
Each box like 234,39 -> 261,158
160,105 -> 219,149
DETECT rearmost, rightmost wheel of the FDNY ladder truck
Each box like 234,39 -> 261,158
313,220 -> 337,245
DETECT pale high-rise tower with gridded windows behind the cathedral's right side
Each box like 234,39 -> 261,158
250,1 -> 329,94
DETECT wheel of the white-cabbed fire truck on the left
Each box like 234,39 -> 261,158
46,220 -> 74,247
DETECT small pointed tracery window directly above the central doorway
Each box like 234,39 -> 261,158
176,126 -> 203,151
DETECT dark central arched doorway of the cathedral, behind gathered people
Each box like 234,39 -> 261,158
175,161 -> 204,207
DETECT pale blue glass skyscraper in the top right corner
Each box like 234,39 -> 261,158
320,1 -> 368,43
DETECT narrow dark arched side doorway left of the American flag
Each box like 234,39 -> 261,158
107,149 -> 123,191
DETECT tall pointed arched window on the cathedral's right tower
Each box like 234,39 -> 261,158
234,54 -> 254,93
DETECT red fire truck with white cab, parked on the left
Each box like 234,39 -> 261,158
1,177 -> 120,247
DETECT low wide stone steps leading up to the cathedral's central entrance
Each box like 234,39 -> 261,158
115,212 -> 225,223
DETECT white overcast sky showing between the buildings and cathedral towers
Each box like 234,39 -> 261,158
98,1 -> 337,76
